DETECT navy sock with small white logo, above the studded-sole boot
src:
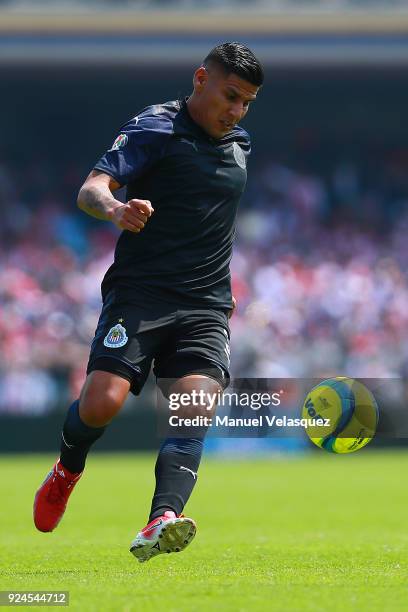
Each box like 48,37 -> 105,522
149,438 -> 204,522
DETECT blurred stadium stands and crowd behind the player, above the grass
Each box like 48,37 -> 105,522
0,0 -> 408,452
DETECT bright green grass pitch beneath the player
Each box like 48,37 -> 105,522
0,449 -> 408,612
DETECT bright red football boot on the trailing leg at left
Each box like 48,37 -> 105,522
34,459 -> 82,531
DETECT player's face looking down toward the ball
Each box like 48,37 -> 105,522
194,67 -> 259,139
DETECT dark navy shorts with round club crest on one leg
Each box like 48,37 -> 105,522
87,292 -> 230,395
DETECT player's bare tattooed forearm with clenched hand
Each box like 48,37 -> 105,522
77,170 -> 153,233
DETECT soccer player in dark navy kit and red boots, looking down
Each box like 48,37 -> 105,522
34,43 -> 263,562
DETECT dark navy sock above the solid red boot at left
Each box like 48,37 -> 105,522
61,400 -> 106,472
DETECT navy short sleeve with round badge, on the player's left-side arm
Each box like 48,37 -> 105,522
94,107 -> 173,185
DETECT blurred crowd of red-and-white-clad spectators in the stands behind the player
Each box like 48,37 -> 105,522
0,150 -> 408,414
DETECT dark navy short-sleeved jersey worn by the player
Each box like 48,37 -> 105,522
95,100 -> 250,309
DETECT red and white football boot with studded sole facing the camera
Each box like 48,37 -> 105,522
130,510 -> 197,563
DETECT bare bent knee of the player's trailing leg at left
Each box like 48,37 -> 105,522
79,371 -> 130,427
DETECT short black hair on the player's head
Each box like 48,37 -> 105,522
203,42 -> 264,87
